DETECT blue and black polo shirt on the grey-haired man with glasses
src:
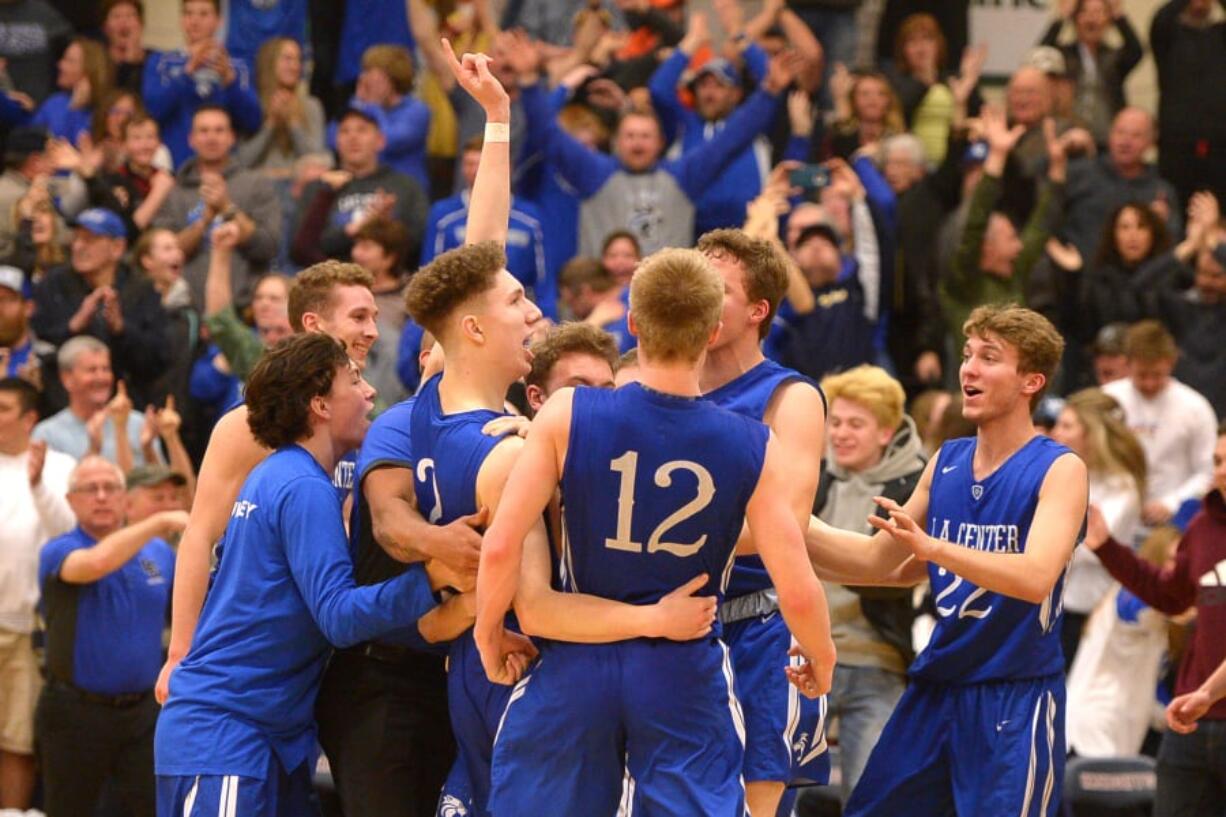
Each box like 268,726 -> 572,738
38,527 -> 174,696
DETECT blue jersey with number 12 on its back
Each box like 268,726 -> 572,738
562,383 -> 769,618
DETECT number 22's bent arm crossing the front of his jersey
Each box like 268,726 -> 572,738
869,454 -> 1090,605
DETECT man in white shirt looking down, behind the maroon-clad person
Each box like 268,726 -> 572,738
1102,320 -> 1217,522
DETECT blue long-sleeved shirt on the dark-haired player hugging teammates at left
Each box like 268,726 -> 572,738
154,445 -> 434,779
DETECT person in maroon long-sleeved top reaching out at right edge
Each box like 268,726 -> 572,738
1085,418 -> 1226,817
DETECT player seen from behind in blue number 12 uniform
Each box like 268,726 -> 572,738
473,250 -> 834,817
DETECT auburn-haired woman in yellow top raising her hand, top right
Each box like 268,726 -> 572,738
885,13 -> 987,166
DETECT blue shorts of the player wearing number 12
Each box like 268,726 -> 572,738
489,638 -> 745,817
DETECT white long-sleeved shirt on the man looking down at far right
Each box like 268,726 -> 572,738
1102,378 -> 1217,512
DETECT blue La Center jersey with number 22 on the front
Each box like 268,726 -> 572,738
911,435 -> 1069,683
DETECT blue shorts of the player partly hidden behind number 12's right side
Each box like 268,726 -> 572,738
723,612 -> 830,785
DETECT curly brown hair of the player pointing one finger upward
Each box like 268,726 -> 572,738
405,242 -> 506,342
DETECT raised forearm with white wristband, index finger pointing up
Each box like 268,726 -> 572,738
443,39 -> 511,244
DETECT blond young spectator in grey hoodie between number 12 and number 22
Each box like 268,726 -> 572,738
813,366 -> 926,801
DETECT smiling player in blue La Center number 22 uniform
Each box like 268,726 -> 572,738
808,305 -> 1089,817
